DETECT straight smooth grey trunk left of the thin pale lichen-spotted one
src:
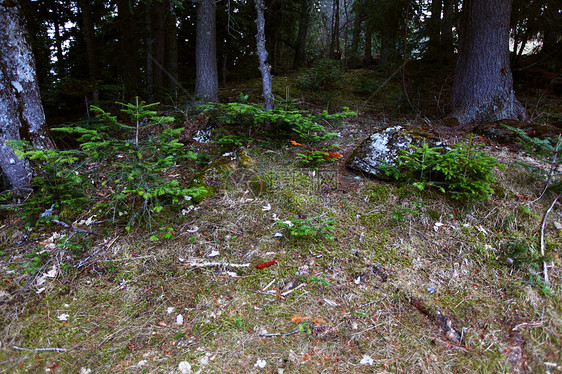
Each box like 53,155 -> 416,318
195,0 -> 219,102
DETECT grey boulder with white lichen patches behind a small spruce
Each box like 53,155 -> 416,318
346,125 -> 442,180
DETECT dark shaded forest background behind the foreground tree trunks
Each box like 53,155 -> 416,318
17,0 -> 561,123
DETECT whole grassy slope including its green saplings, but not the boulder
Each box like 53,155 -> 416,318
0,65 -> 562,373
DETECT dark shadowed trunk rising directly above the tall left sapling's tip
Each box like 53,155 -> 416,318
117,0 -> 138,97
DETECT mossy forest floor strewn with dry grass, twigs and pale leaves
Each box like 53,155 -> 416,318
0,64 -> 562,374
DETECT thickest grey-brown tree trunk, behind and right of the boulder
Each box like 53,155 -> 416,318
450,0 -> 526,125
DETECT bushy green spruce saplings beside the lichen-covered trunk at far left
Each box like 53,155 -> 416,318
5,102 -> 207,228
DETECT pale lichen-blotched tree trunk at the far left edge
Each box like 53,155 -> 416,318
0,1 -> 53,192
